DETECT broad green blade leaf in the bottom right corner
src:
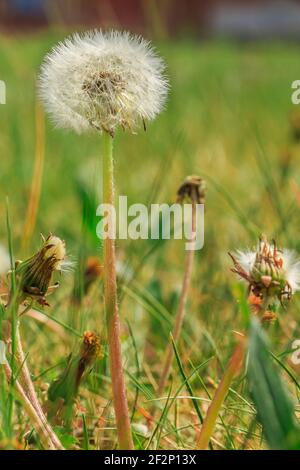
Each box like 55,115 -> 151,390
248,320 -> 300,450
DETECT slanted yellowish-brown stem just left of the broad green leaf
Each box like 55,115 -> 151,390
197,338 -> 245,450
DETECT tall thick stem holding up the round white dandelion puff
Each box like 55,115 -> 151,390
103,132 -> 133,450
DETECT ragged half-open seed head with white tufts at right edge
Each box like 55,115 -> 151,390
230,237 -> 300,302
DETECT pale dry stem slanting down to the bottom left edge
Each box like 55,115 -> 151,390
4,364 -> 64,450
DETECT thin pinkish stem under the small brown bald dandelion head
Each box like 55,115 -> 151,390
157,198 -> 197,396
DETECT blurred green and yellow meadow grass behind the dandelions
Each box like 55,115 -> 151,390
0,32 -> 300,449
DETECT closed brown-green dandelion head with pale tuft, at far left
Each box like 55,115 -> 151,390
16,235 -> 68,305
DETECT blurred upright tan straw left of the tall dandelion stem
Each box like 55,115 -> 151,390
23,102 -> 45,251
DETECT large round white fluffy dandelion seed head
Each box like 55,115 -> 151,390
39,30 -> 168,135
